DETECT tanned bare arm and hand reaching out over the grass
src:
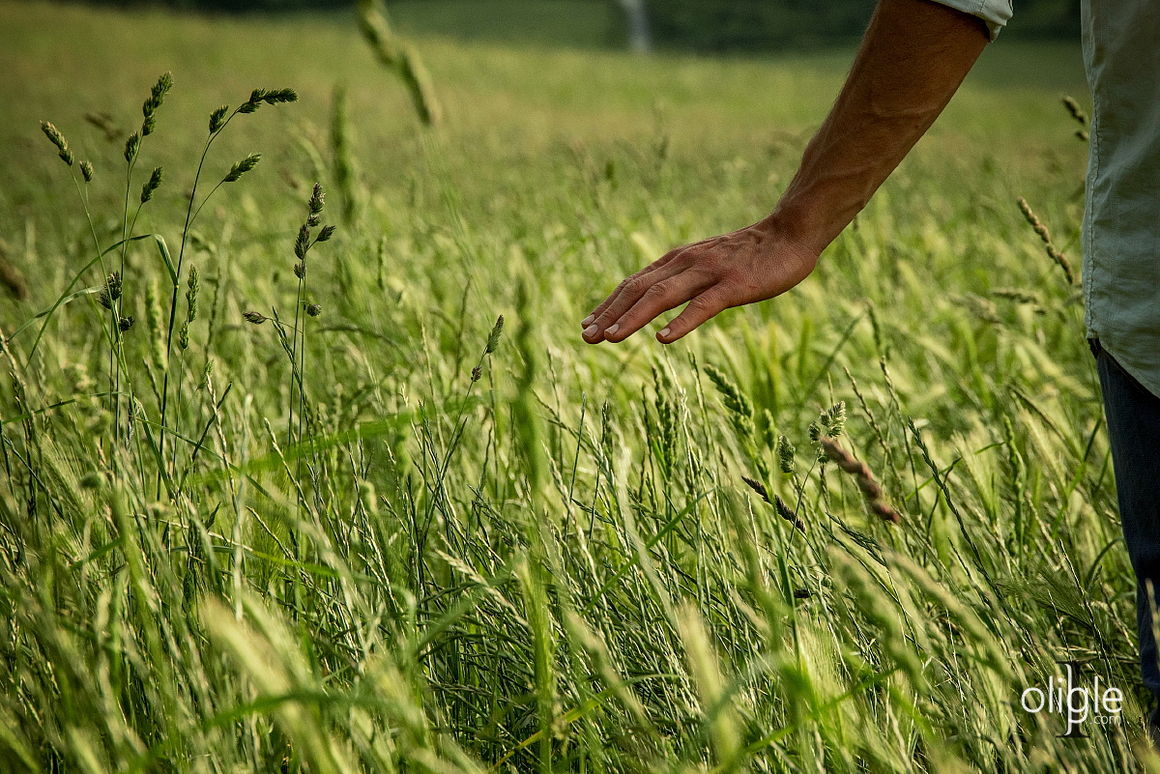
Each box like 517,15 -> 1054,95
581,0 -> 987,343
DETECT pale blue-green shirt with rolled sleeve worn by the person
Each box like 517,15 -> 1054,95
935,0 -> 1160,396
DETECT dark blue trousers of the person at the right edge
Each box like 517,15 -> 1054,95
1088,339 -> 1160,725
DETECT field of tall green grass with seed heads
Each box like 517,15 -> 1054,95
0,2 -> 1151,774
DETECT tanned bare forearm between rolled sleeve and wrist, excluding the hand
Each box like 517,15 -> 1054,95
768,0 -> 987,253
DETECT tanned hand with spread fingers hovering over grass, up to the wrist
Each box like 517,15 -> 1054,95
581,218 -> 818,343
